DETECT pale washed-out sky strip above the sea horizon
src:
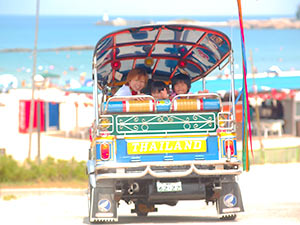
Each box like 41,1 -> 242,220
0,0 -> 300,16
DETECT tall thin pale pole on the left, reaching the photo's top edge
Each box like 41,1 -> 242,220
28,0 -> 40,159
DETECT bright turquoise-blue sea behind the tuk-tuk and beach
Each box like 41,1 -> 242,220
0,15 -> 300,85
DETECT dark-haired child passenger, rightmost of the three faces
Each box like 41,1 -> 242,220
171,73 -> 191,98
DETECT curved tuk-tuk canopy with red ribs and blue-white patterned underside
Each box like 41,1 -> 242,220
93,25 -> 231,88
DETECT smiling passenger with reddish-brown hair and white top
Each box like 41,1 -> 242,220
114,68 -> 148,96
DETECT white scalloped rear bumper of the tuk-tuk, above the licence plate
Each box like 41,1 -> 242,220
95,161 -> 242,181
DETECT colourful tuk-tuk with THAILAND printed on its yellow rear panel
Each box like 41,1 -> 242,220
87,24 -> 244,223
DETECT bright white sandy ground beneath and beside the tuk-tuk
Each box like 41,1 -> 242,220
0,163 -> 300,225
